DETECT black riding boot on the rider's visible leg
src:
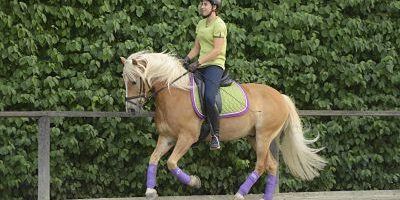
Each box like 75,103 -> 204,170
206,106 -> 221,150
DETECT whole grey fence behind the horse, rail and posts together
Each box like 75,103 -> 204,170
0,110 -> 400,200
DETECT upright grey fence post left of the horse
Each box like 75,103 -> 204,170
38,116 -> 50,200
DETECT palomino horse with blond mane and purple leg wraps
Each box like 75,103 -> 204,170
121,52 -> 326,200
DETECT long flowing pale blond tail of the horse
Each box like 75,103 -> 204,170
280,95 -> 326,180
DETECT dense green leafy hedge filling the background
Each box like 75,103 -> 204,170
0,0 -> 400,199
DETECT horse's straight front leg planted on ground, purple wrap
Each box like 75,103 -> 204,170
146,135 -> 175,199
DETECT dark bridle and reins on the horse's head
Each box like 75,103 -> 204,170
125,71 -> 189,109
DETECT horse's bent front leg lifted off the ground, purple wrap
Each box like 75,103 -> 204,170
167,135 -> 201,188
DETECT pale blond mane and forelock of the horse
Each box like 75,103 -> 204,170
123,51 -> 190,90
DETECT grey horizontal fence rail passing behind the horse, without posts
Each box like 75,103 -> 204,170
0,110 -> 400,118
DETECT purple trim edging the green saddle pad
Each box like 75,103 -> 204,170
190,75 -> 250,119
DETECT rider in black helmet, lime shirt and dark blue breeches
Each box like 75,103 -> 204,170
183,0 -> 227,150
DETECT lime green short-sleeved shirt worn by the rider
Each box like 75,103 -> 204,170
196,16 -> 227,69
